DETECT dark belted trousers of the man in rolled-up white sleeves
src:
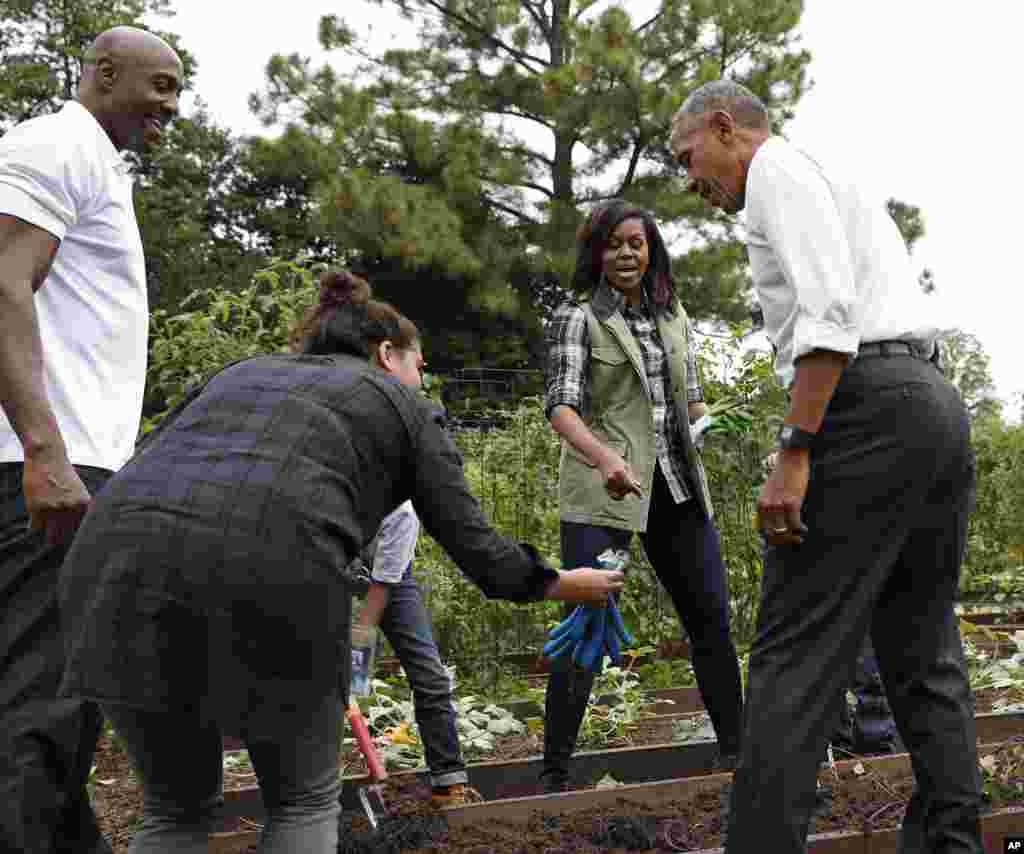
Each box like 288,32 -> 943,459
726,355 -> 982,854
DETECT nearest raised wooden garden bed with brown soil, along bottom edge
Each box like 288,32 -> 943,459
211,740 -> 1024,854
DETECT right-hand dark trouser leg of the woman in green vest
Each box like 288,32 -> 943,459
640,470 -> 743,757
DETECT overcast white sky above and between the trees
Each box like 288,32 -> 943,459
154,0 -> 1024,416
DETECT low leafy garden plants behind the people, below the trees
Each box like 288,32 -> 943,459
148,261 -> 1024,685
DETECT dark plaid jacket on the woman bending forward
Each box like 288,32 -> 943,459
60,354 -> 554,720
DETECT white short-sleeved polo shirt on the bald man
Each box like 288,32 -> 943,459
0,101 -> 148,471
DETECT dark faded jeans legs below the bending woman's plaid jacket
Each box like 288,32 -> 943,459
103,696 -> 341,854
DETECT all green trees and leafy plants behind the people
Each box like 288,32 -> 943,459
6,0 -> 1024,692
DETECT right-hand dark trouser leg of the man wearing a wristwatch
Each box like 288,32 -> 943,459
872,393 -> 981,854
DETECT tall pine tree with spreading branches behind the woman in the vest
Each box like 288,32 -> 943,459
252,0 -> 810,331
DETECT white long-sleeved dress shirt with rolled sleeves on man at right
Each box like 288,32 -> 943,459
745,136 -> 940,387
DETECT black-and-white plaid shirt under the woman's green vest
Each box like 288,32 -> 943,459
545,285 -> 703,504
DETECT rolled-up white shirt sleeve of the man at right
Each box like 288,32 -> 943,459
746,146 -> 860,361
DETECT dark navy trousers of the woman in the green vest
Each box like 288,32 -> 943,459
544,468 -> 742,776
